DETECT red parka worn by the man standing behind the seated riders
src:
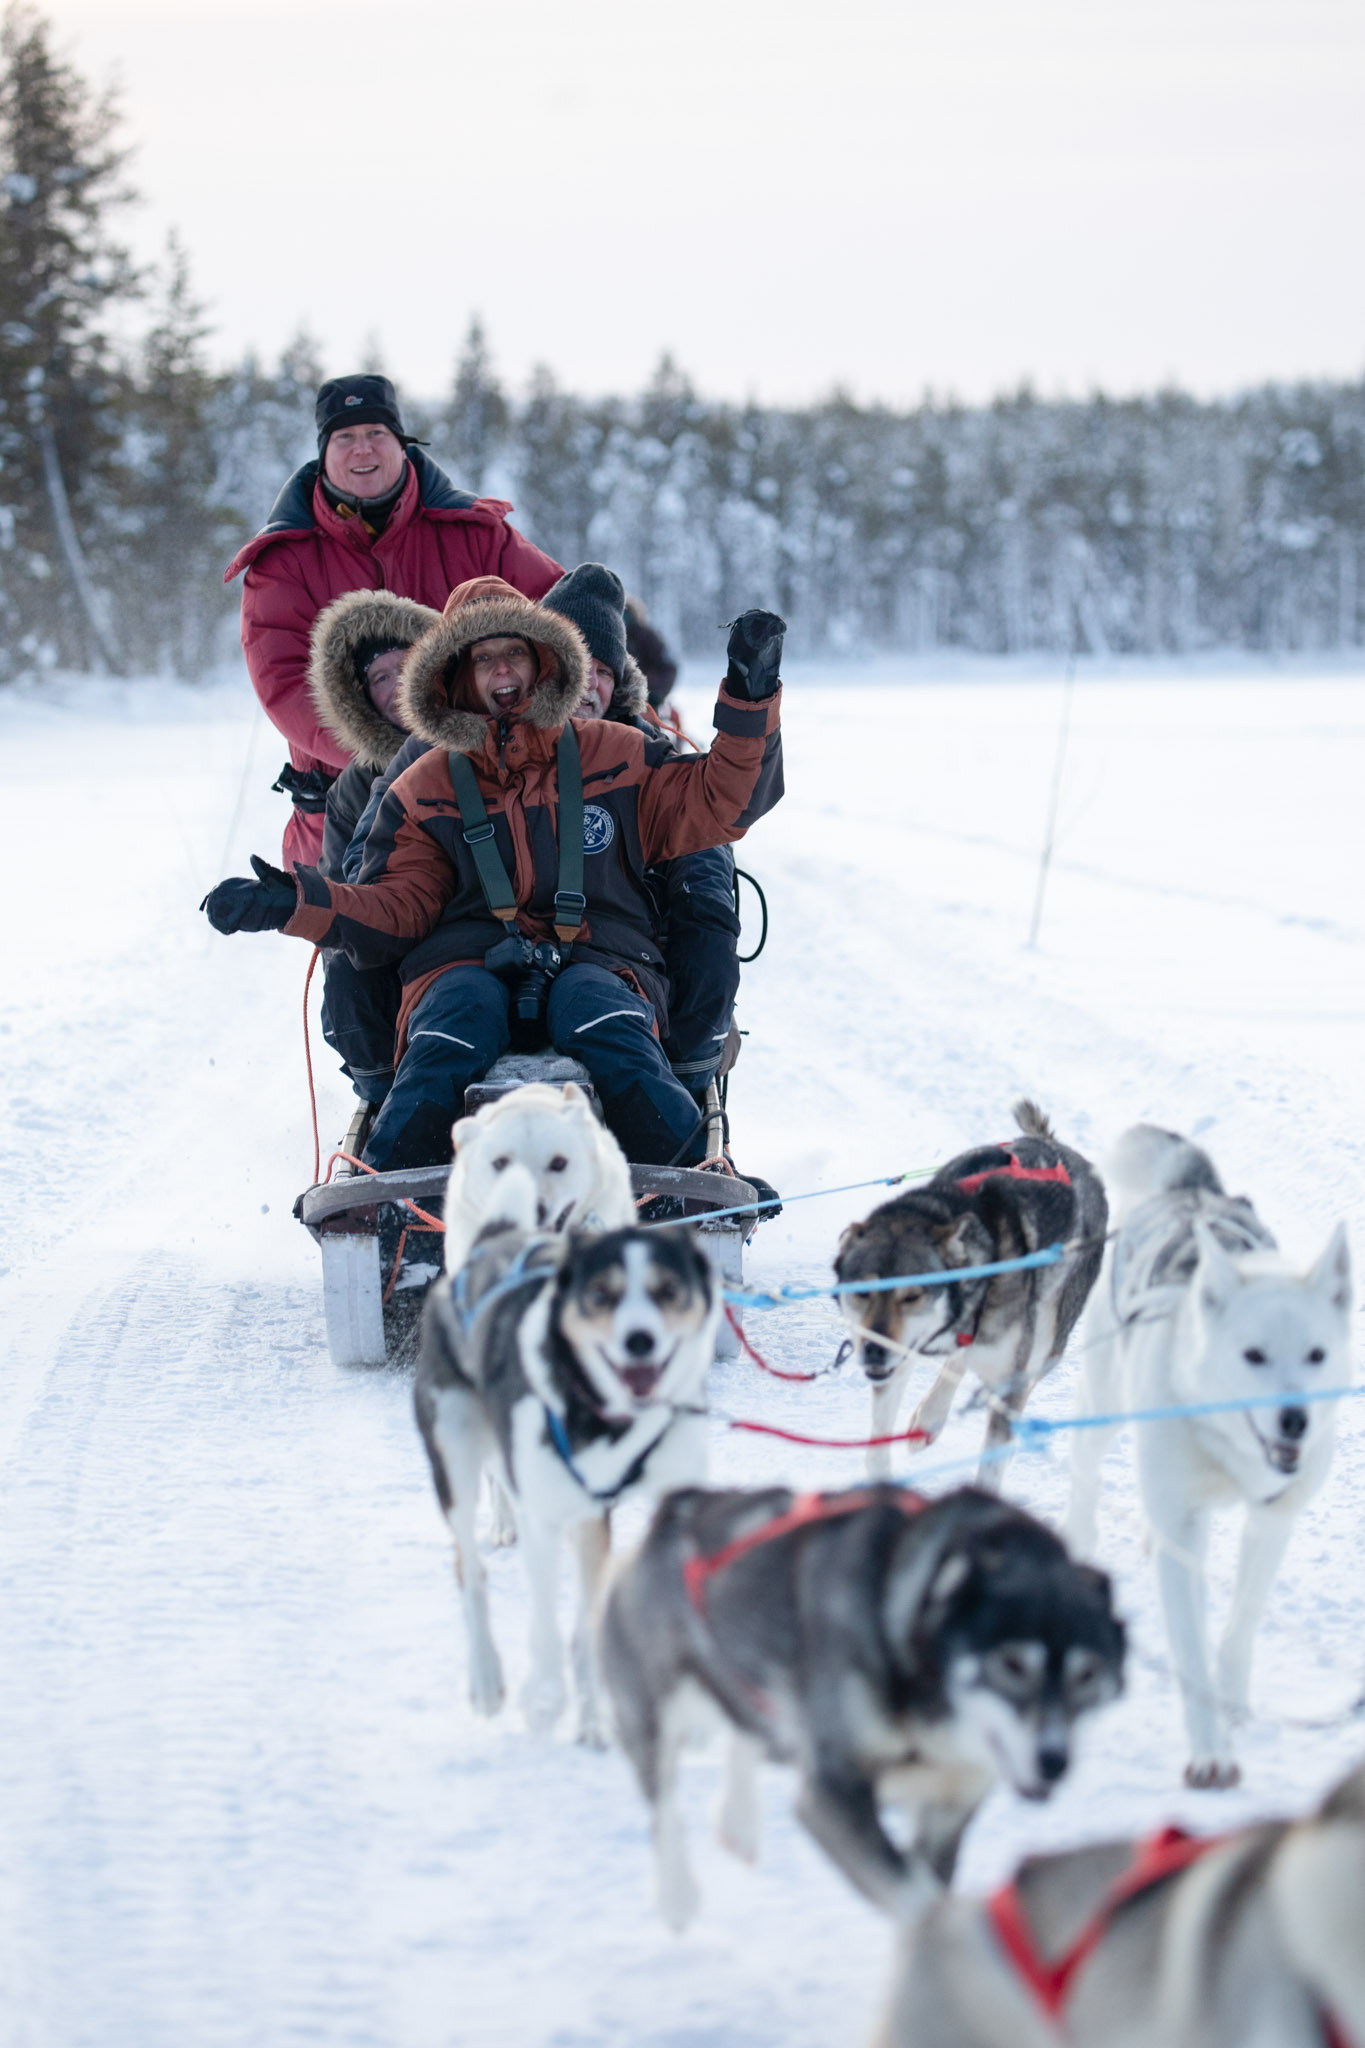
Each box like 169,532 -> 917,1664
225,449 -> 563,866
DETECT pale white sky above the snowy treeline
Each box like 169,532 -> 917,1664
43,0 -> 1365,401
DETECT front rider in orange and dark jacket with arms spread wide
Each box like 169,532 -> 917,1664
205,586 -> 784,1171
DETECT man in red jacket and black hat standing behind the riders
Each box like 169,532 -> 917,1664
225,375 -> 561,864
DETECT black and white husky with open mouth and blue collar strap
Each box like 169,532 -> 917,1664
413,1165 -> 720,1745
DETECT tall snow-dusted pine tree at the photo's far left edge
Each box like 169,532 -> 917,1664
0,6 -> 139,670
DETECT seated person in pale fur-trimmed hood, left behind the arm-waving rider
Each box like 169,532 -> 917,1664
309,590 -> 440,1102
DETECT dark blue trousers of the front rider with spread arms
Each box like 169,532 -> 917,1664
364,963 -> 704,1174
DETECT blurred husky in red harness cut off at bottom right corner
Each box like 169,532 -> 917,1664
876,1767 -> 1365,2048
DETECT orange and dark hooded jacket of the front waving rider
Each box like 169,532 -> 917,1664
284,578 -> 782,1030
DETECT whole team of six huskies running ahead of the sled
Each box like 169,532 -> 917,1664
415,1083 -> 1365,2048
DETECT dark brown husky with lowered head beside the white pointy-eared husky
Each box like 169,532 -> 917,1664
835,1102 -> 1109,1487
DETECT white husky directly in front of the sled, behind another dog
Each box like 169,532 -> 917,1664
446,1081 -> 634,1272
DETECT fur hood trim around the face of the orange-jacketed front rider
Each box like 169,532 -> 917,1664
399,578 -> 587,754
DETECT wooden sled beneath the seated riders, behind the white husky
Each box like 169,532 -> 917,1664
295,1051 -> 759,1366
